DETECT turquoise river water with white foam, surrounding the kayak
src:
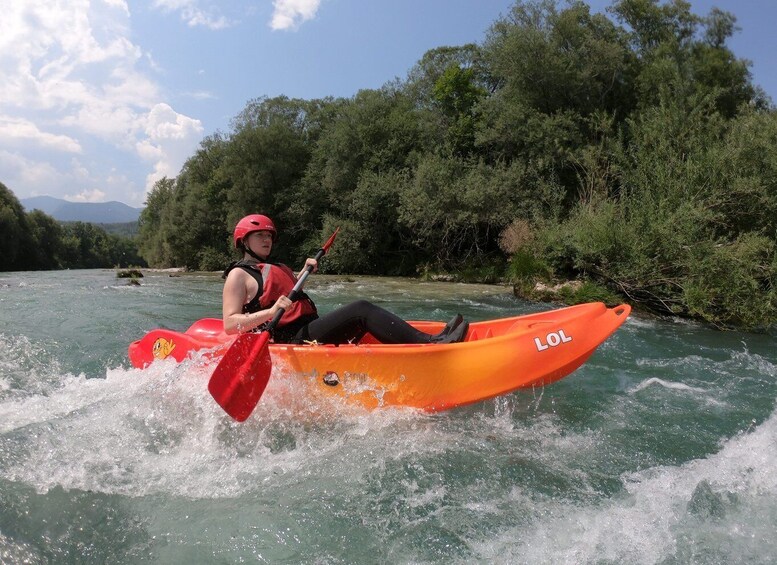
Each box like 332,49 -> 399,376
0,271 -> 777,564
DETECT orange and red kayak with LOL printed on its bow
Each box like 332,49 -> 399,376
129,302 -> 631,411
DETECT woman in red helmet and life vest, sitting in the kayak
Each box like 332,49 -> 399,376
222,214 -> 469,344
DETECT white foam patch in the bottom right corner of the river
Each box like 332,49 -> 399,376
472,412 -> 777,564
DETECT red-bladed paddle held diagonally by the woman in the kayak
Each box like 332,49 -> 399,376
208,228 -> 340,422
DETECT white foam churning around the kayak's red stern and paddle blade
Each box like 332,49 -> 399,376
0,352 -> 436,498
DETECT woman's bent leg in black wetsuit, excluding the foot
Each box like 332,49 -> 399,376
296,300 -> 446,344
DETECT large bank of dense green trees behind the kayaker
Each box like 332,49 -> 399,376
4,0 -> 777,327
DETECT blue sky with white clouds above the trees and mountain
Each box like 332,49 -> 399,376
0,0 -> 777,207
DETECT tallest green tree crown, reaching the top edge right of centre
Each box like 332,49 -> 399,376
475,0 -> 638,209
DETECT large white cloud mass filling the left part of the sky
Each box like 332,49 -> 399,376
0,0 -> 205,204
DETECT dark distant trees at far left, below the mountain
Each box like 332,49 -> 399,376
0,183 -> 145,271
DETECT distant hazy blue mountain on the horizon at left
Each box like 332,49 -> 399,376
20,196 -> 142,224
